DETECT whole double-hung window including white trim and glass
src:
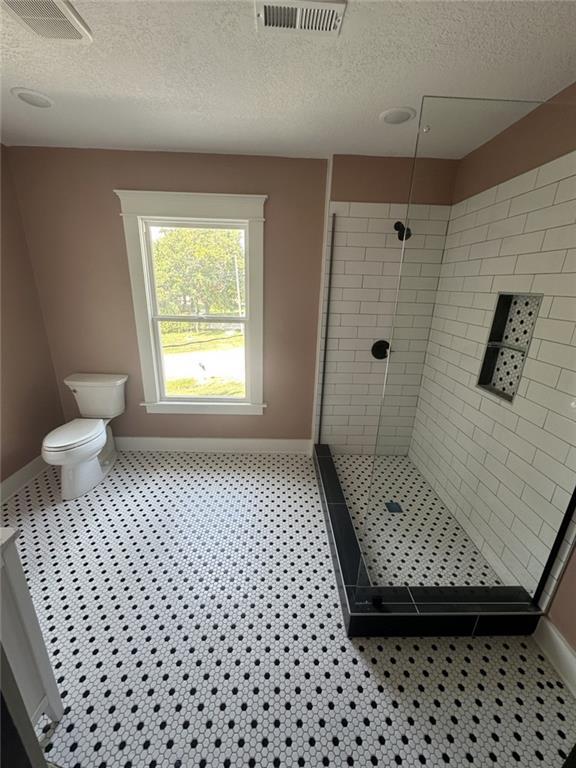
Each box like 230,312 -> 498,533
116,190 -> 266,414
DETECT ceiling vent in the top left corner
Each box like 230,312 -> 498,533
2,0 -> 92,42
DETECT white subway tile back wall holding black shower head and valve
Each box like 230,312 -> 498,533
321,202 -> 450,455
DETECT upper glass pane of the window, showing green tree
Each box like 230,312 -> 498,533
150,226 -> 246,316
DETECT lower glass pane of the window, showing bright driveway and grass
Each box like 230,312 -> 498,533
159,320 -> 246,398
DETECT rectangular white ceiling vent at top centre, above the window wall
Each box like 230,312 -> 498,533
256,0 -> 346,36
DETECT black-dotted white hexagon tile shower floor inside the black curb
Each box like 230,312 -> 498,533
334,455 -> 502,587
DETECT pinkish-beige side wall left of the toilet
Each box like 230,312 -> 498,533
0,148 -> 63,479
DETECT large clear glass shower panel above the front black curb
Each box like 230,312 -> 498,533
364,97 -> 576,594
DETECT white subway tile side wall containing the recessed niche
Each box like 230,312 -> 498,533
410,152 -> 576,596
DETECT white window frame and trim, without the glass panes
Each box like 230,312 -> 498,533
114,189 -> 267,415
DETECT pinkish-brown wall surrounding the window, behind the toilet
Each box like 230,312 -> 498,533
8,147 -> 326,438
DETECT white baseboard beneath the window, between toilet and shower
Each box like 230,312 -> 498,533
116,437 -> 313,456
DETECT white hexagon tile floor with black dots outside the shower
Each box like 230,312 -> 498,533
3,453 -> 576,768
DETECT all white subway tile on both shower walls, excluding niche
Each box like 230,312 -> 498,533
322,152 -> 576,605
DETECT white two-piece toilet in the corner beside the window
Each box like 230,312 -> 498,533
42,373 -> 128,499
